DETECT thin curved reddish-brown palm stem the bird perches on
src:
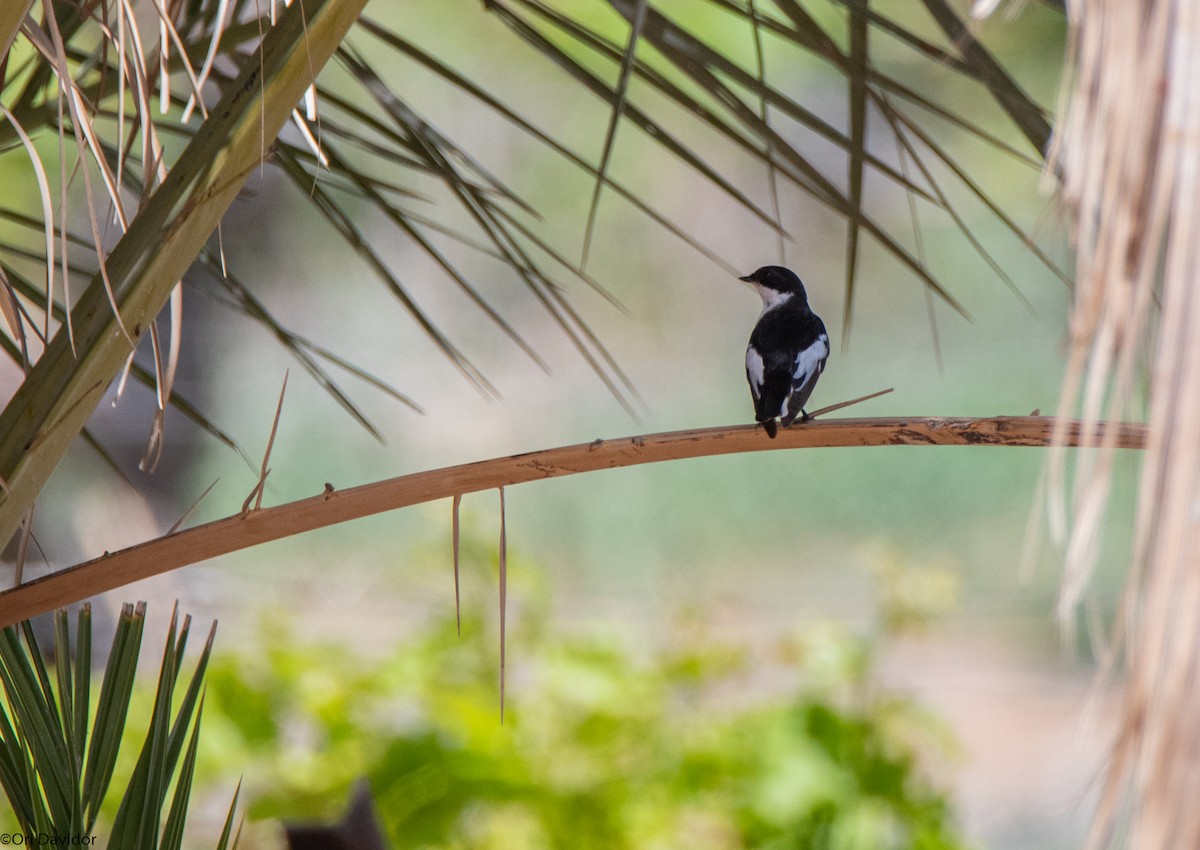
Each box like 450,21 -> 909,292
0,417 -> 1147,625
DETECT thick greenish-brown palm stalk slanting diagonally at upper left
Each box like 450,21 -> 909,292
0,0 -> 361,538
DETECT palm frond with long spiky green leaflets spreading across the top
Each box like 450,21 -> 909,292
0,0 -> 1066,547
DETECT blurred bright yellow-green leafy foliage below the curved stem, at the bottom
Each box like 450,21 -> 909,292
189,541 -> 966,850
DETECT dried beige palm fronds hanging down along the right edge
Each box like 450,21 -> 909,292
1050,0 -> 1200,848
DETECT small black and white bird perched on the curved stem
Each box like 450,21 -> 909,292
738,265 -> 829,439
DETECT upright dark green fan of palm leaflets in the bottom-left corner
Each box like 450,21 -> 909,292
0,603 -> 232,850
